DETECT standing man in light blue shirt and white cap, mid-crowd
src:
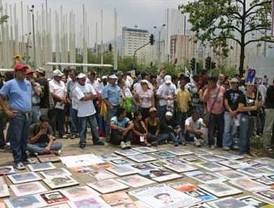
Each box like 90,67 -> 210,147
101,74 -> 122,140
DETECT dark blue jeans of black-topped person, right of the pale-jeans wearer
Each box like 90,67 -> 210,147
239,114 -> 254,154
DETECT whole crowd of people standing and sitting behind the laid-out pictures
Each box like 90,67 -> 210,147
0,57 -> 274,169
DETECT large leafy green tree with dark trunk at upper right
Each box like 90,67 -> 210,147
179,0 -> 273,76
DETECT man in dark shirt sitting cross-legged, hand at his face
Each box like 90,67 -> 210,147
27,115 -> 62,155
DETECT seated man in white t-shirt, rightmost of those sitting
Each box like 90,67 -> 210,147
185,110 -> 207,147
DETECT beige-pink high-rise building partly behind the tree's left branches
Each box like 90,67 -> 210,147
170,35 -> 197,64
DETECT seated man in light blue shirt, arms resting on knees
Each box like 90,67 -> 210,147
109,108 -> 133,149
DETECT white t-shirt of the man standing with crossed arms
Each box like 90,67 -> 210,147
74,83 -> 97,117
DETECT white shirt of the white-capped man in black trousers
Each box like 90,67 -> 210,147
49,79 -> 67,109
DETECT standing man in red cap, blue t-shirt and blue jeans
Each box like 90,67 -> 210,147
0,63 -> 31,170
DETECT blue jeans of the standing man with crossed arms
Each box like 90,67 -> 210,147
79,114 -> 99,144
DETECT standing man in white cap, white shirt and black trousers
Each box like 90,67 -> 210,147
49,69 -> 67,138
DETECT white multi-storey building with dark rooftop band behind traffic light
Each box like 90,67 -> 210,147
122,27 -> 151,63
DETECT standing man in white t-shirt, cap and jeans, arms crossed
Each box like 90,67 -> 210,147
73,73 -> 104,149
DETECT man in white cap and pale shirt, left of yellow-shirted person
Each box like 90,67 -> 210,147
157,75 -> 176,118
